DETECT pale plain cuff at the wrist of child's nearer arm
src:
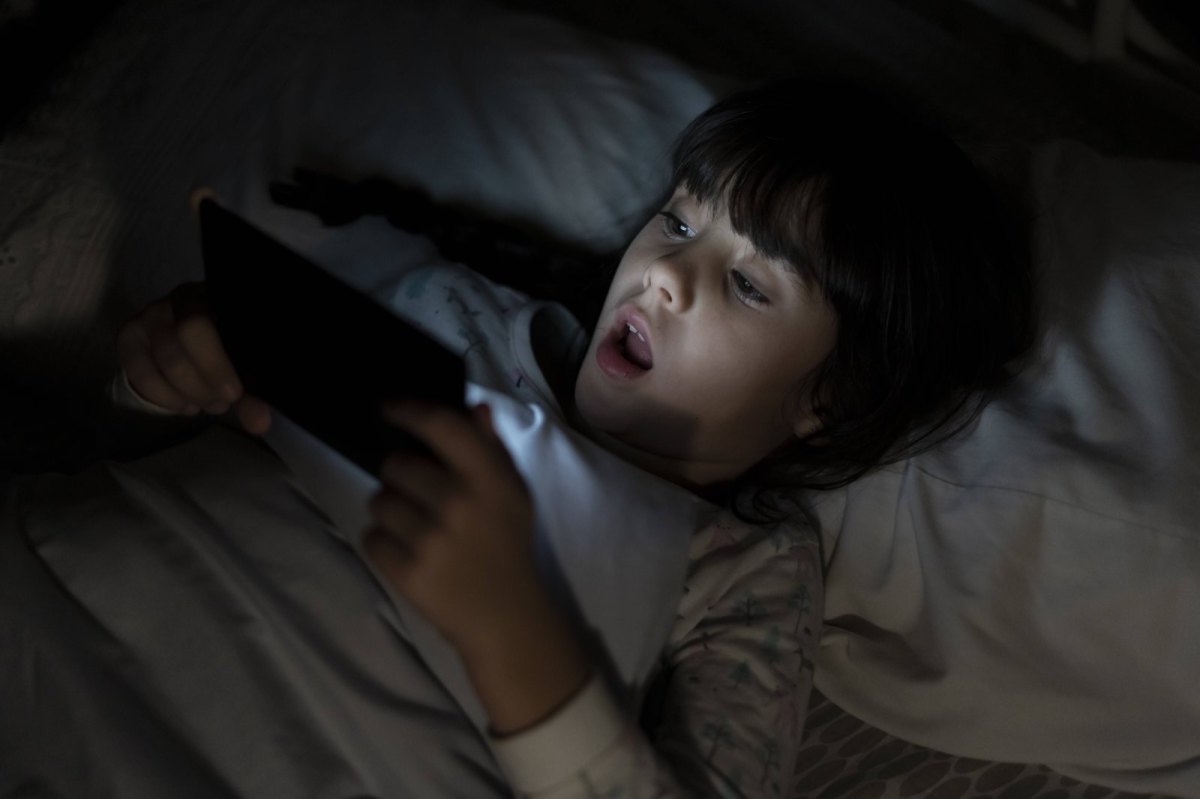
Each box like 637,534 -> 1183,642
487,674 -> 628,793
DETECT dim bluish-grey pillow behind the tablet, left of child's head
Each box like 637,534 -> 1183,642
0,0 -> 715,393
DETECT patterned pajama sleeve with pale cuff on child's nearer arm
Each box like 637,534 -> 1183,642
492,515 -> 821,799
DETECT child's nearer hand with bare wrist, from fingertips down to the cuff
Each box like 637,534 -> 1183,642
365,405 -> 590,734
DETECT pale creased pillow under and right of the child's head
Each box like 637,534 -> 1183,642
816,143 -> 1200,797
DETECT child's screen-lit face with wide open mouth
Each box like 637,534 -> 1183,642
575,191 -> 836,486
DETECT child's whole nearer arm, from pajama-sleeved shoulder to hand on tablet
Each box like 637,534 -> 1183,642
366,409 -> 820,798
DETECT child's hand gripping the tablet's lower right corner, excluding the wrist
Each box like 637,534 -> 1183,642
365,404 -> 545,651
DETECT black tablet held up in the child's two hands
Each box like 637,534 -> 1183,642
197,198 -> 466,475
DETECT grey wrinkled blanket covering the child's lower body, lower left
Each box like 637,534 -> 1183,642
0,425 -> 506,799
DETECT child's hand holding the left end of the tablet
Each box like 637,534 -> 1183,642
116,283 -> 271,435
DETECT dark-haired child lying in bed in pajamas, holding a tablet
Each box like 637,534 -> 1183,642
110,82 -> 1032,797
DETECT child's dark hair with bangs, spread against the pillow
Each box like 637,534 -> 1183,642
672,80 -> 1034,522
